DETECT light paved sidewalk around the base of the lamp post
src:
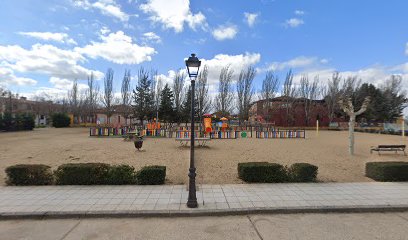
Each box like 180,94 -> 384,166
0,182 -> 408,219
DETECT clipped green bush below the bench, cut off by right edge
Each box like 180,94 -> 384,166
365,162 -> 408,182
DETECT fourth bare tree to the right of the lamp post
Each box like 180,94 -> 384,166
261,71 -> 279,122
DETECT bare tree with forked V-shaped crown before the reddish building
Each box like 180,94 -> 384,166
299,75 -> 319,126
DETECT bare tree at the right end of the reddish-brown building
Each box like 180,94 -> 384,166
324,72 -> 341,122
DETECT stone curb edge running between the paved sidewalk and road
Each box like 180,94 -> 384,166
0,205 -> 408,220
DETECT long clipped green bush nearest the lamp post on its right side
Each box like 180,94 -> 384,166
238,162 -> 288,183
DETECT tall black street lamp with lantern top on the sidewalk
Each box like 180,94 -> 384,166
186,53 -> 201,208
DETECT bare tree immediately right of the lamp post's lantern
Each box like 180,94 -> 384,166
196,65 -> 211,119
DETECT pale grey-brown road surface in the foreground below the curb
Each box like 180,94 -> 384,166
0,212 -> 408,240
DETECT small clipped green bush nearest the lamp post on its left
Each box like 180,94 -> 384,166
136,165 -> 166,185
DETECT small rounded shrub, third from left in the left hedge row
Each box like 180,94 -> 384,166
107,164 -> 136,185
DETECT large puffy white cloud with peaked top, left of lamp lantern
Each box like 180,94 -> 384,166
75,31 -> 156,64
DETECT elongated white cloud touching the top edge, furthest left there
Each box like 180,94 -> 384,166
72,0 -> 129,22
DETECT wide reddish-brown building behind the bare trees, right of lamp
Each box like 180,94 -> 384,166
248,97 -> 344,127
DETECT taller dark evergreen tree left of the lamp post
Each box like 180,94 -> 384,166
133,68 -> 154,123
